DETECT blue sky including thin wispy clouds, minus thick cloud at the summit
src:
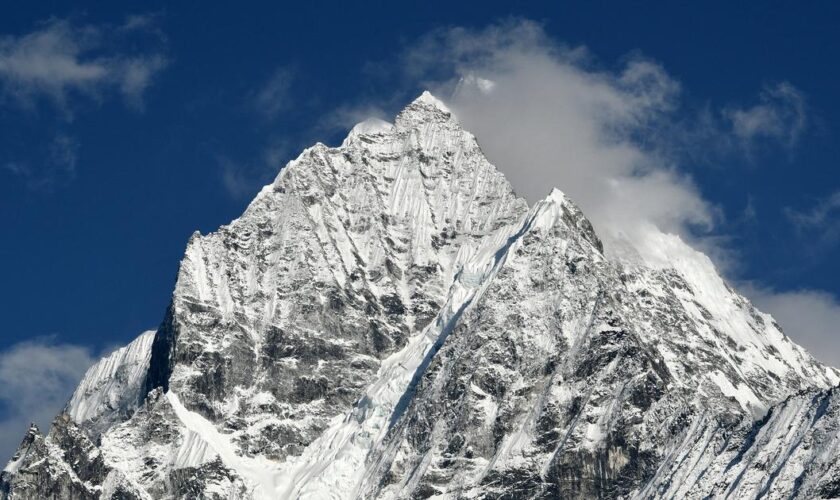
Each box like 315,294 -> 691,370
0,1 -> 840,453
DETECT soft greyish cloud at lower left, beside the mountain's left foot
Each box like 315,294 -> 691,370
0,338 -> 95,462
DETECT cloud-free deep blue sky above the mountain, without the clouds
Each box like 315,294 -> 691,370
0,1 -> 840,350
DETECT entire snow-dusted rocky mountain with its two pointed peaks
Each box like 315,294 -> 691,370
0,93 -> 840,499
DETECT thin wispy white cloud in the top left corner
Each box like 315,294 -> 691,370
0,17 -> 166,112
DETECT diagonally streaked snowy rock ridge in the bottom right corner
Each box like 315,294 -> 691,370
637,388 -> 840,498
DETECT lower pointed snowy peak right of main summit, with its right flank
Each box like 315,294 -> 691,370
361,191 -> 837,498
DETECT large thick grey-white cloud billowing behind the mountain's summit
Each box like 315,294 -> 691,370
406,22 -> 715,260
